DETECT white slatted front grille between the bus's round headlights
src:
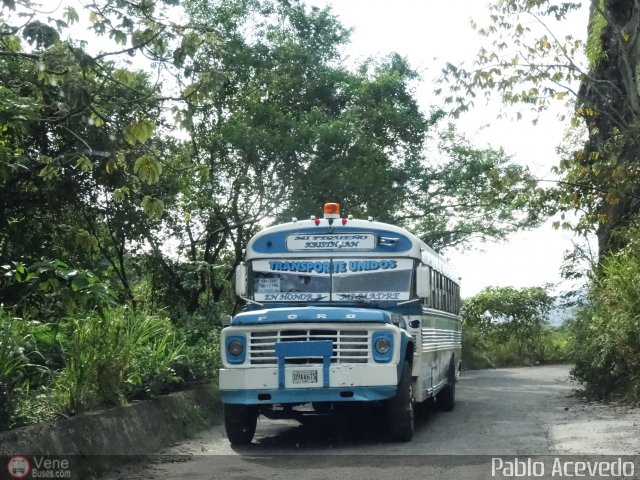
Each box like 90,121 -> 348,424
247,328 -> 370,365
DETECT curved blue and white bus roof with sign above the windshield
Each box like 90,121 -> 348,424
246,218 -> 458,283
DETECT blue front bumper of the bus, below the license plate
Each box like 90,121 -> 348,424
220,385 -> 396,405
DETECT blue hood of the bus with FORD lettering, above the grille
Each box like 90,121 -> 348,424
231,307 -> 391,326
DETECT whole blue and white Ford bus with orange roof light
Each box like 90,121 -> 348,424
219,203 -> 461,444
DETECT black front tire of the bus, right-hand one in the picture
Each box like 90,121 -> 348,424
386,360 -> 415,442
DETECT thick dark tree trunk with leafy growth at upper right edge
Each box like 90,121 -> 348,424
578,0 -> 640,256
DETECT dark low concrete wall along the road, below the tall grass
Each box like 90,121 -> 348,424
0,385 -> 222,475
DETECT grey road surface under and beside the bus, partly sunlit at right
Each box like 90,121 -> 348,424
109,366 -> 640,480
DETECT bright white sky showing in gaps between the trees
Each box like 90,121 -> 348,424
306,0 -> 588,297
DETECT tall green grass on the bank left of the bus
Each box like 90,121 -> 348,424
0,307 -> 219,430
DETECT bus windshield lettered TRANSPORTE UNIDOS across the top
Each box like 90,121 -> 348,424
250,258 -> 413,302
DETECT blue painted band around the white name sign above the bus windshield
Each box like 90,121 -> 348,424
249,225 -> 413,254
